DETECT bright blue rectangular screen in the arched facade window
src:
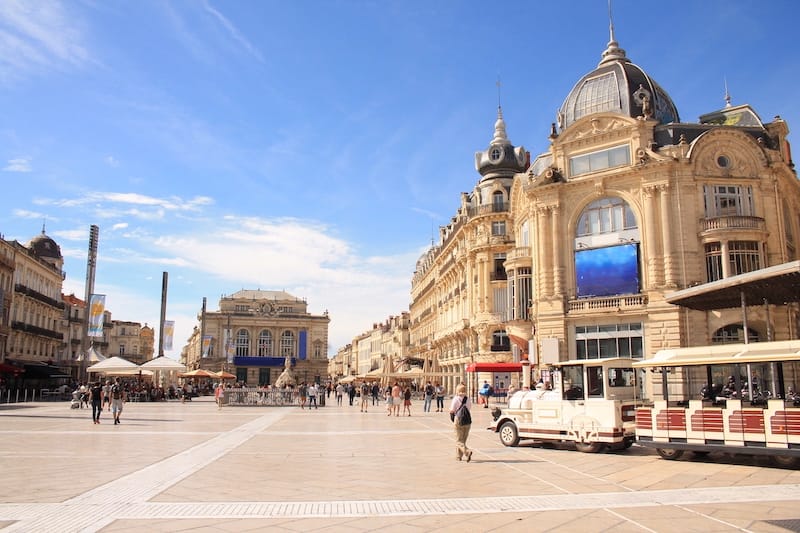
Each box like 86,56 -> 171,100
575,243 -> 639,298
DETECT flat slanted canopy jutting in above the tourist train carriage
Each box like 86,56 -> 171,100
665,261 -> 800,311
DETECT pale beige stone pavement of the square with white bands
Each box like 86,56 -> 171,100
0,397 -> 800,533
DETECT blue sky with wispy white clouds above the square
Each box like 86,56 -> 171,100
0,0 -> 800,357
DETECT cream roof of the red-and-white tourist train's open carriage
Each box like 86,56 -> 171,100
633,340 -> 800,367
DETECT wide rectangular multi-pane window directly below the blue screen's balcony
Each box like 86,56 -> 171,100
575,322 -> 644,359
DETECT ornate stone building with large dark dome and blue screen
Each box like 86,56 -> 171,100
505,28 -> 800,390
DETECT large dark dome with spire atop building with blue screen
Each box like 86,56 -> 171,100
558,26 -> 680,131
